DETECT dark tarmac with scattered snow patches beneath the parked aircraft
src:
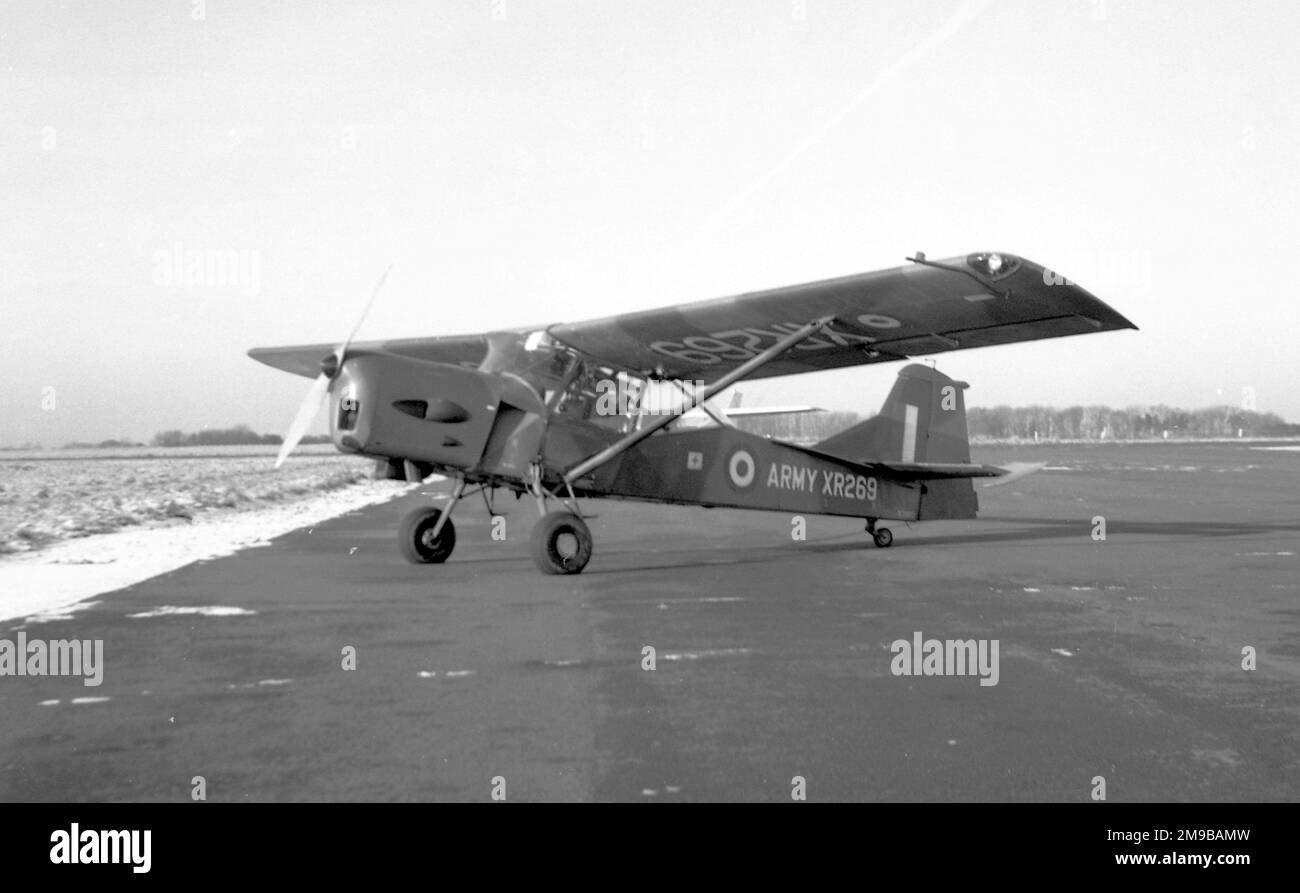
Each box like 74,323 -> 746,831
0,443 -> 1300,802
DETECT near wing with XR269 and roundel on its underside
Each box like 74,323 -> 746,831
547,253 -> 1138,382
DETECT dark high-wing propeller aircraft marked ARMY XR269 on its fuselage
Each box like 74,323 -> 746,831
248,252 -> 1138,575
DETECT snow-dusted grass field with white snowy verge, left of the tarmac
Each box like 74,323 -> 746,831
0,446 -> 412,623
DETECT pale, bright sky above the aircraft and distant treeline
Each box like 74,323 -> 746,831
0,0 -> 1300,446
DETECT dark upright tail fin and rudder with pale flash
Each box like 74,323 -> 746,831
813,363 -> 979,519
